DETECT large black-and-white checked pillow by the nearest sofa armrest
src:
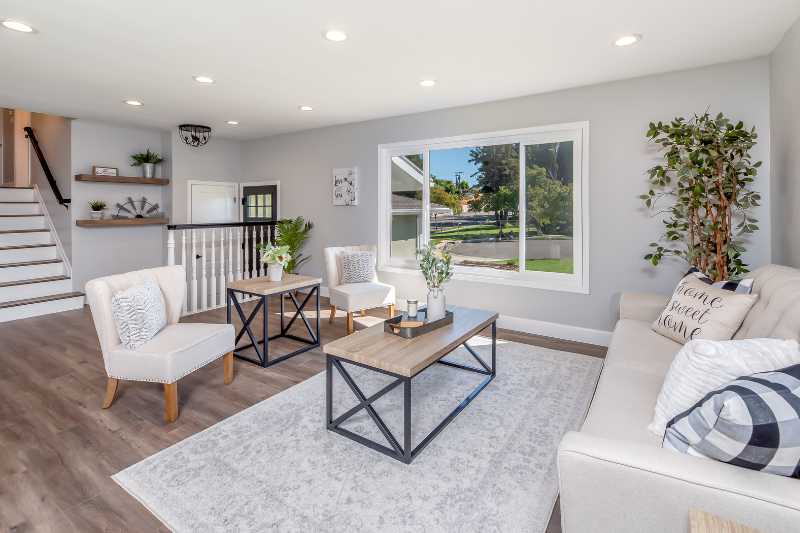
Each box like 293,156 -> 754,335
662,365 -> 800,477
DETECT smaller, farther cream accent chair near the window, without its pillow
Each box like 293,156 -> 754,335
325,245 -> 394,335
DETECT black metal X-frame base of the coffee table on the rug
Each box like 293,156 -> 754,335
325,320 -> 497,464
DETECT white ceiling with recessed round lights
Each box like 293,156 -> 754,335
0,0 -> 800,139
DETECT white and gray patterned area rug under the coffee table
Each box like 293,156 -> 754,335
114,339 -> 603,533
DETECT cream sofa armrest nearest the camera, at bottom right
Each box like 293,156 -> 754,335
558,432 -> 800,533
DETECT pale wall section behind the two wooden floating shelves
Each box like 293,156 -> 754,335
71,120 -> 166,291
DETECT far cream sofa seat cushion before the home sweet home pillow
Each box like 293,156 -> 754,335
605,319 -> 683,376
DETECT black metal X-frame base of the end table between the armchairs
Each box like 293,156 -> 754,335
226,283 -> 320,368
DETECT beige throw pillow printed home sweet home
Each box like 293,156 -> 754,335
652,275 -> 758,344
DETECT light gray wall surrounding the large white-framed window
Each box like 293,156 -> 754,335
242,57 -> 771,331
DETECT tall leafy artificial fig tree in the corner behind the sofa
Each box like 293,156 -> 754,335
640,112 -> 761,281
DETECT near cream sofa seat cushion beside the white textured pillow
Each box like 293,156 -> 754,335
581,364 -> 664,448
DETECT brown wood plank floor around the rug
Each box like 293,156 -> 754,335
0,298 -> 605,533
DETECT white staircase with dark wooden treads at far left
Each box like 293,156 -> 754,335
0,187 -> 84,322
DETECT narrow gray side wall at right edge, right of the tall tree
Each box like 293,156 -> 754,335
769,15 -> 800,268
